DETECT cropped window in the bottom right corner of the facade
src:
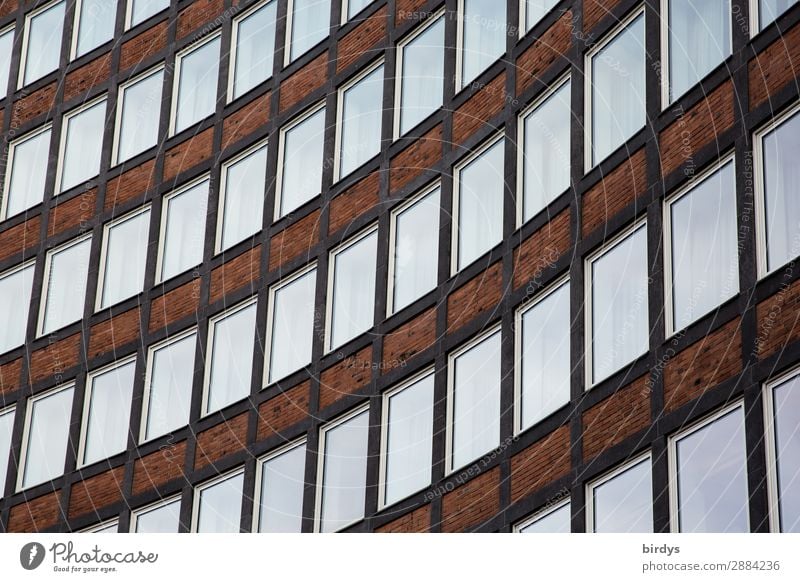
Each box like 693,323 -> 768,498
768,376 -> 800,533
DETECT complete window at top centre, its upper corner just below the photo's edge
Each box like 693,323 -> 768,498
395,15 -> 444,137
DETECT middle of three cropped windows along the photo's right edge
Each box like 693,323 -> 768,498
761,113 -> 800,271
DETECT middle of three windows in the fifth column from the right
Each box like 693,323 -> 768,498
452,136 -> 506,273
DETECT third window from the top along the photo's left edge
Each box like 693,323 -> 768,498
0,261 -> 35,356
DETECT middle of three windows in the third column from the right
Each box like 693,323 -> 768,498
587,224 -> 649,385
